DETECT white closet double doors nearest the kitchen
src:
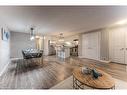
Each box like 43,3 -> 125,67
82,32 -> 99,60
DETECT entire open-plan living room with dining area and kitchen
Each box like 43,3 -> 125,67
0,6 -> 127,90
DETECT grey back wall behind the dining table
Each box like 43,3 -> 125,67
10,32 -> 36,58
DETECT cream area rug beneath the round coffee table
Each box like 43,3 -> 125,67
51,76 -> 127,90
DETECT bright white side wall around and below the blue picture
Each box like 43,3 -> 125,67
0,27 -> 10,74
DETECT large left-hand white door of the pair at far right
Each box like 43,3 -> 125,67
109,28 -> 125,63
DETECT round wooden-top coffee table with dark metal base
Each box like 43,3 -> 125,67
73,68 -> 115,89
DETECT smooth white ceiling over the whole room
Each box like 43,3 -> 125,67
0,6 -> 127,36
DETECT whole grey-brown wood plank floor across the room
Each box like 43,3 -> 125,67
0,56 -> 127,89
